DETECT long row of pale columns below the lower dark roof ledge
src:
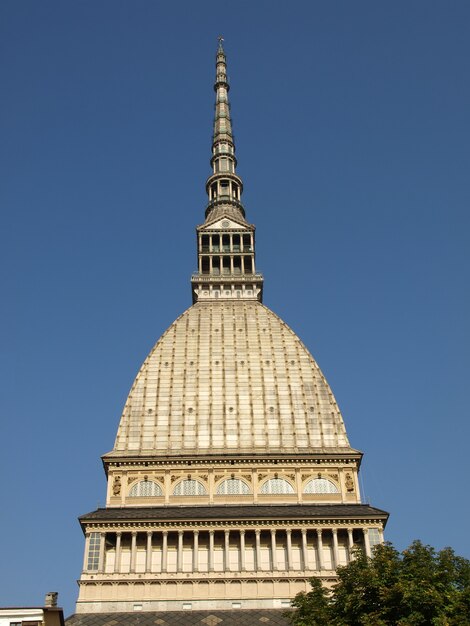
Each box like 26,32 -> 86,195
84,528 -> 382,574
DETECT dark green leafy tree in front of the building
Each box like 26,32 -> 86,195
289,541 -> 470,626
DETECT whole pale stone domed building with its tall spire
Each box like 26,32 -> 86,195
69,41 -> 388,626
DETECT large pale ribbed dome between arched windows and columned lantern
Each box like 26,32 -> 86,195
112,300 -> 350,456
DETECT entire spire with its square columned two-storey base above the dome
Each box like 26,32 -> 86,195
191,37 -> 263,302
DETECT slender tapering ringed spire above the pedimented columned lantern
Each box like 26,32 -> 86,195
206,37 -> 245,219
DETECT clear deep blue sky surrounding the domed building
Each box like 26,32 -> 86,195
0,0 -> 470,613
